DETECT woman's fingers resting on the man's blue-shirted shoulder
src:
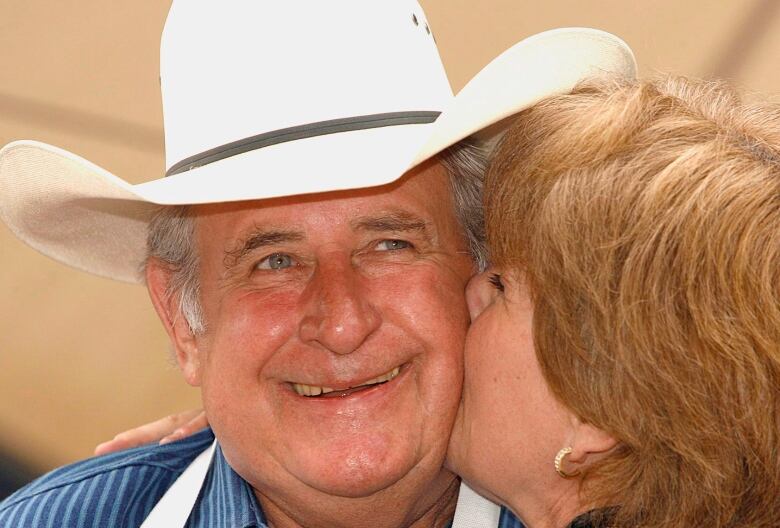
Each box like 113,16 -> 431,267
95,409 -> 209,455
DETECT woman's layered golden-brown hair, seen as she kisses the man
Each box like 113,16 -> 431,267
485,78 -> 780,528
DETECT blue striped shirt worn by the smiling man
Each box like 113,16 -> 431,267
0,429 -> 523,528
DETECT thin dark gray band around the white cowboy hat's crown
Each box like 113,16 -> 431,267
165,111 -> 441,176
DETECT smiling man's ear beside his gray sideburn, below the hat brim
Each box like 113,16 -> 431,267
146,258 -> 201,386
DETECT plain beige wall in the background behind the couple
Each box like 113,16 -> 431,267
0,0 -> 780,469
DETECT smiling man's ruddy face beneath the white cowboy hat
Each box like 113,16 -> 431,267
179,163 -> 473,508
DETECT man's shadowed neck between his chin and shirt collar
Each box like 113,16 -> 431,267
255,470 -> 460,528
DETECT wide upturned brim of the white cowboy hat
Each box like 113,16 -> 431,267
0,28 -> 636,282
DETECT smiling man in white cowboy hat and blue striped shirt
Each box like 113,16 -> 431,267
0,0 -> 634,527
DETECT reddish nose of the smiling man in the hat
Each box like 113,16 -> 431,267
299,257 -> 381,354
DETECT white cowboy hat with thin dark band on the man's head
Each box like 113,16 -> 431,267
0,0 -> 636,282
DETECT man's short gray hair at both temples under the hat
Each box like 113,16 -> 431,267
140,141 -> 487,334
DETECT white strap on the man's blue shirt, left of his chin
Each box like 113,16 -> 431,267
141,440 -> 217,528
